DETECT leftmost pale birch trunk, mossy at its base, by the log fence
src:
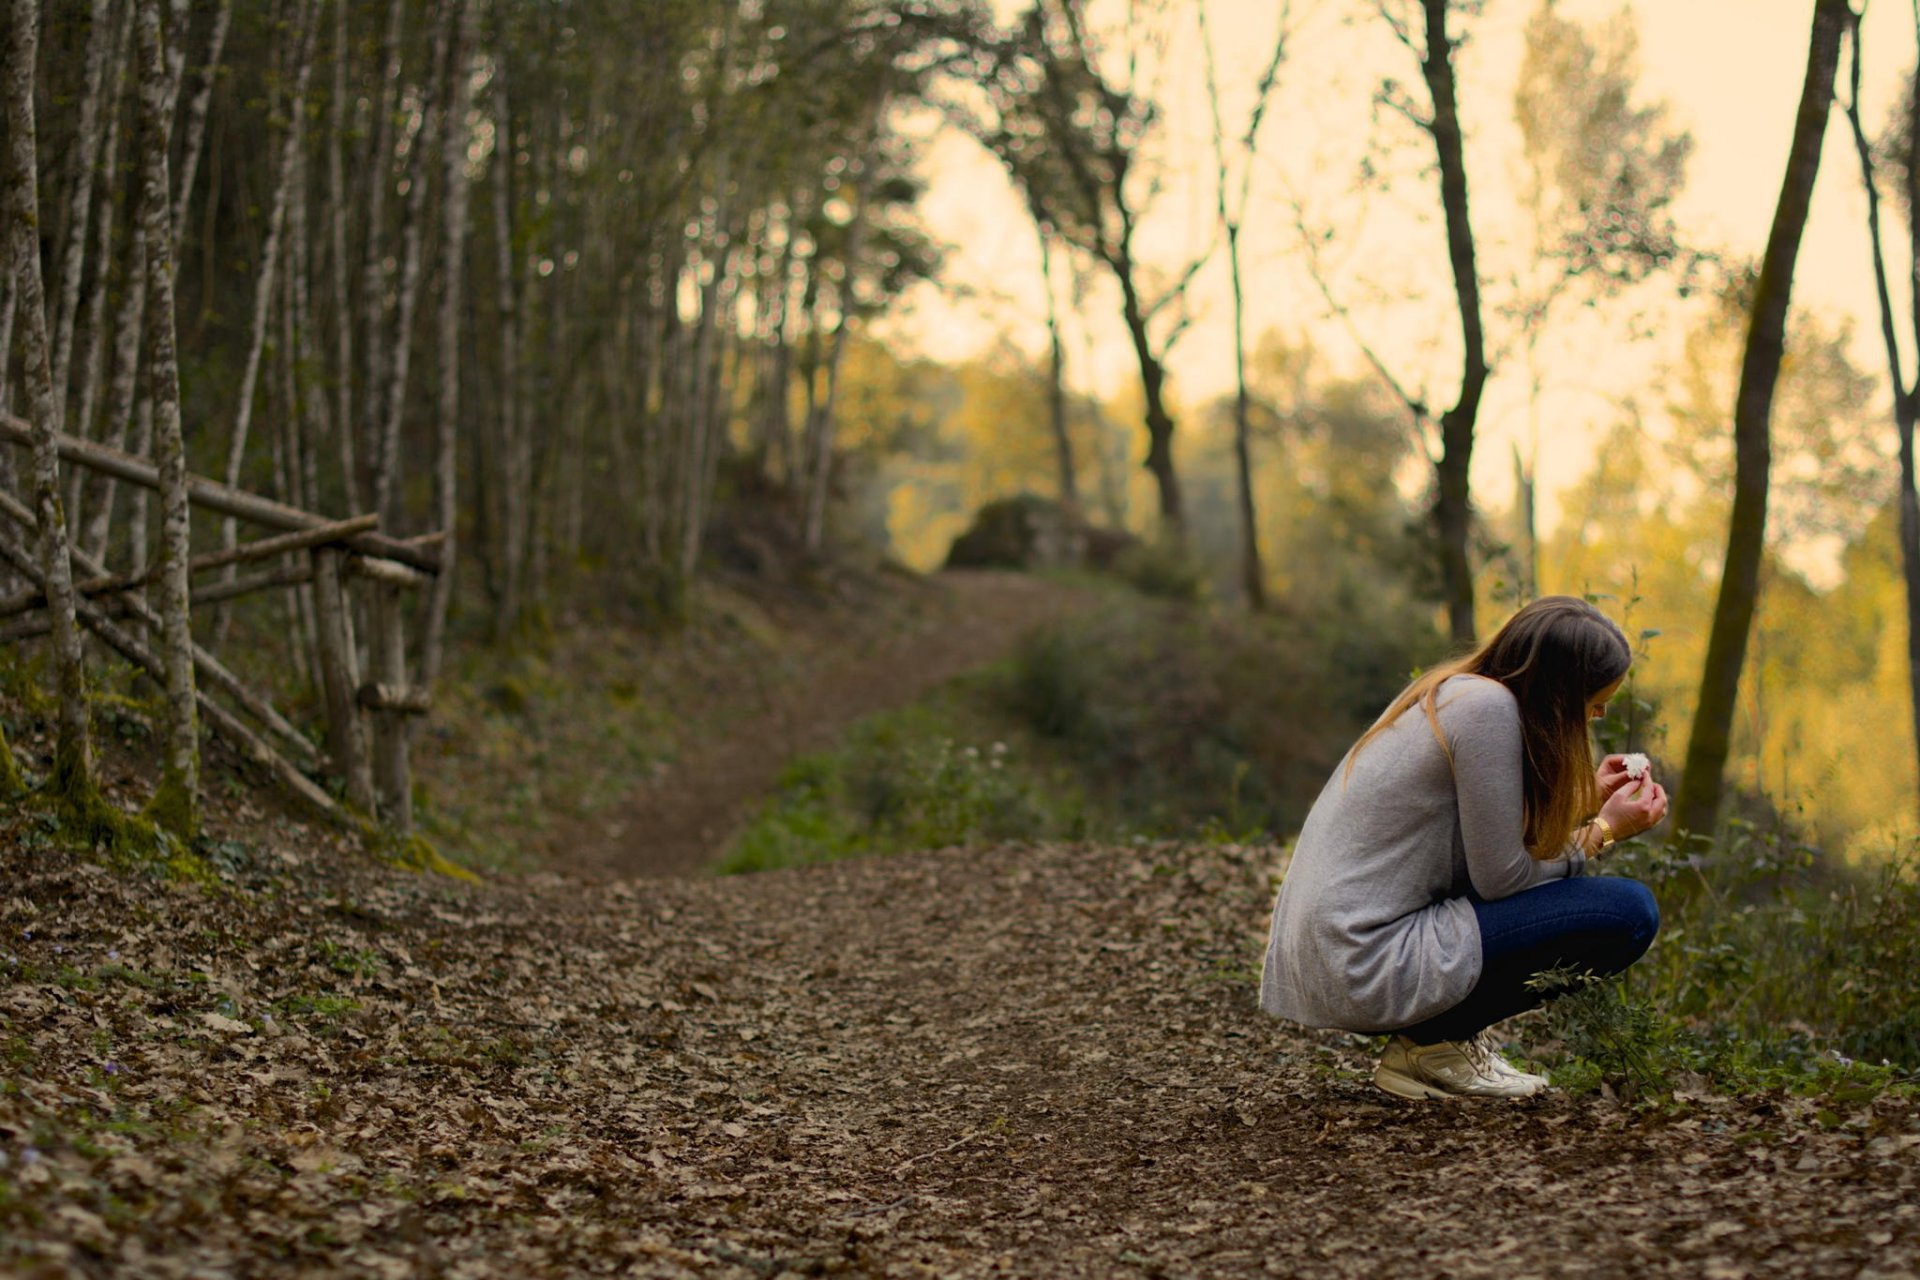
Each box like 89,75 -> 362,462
0,0 -> 94,806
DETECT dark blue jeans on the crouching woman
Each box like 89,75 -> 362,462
1400,875 -> 1661,1044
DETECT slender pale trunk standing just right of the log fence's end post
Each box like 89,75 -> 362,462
415,0 -> 472,702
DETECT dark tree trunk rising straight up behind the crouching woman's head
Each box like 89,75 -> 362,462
1421,0 -> 1486,645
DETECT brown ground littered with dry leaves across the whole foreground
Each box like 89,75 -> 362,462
0,837 -> 1920,1280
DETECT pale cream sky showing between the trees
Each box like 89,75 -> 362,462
887,0 -> 1914,571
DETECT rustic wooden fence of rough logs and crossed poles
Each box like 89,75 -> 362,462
0,415 -> 444,837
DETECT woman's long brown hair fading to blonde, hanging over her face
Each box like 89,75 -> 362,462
1346,595 -> 1634,860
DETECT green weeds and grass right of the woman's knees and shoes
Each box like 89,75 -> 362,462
1542,821 -> 1920,1096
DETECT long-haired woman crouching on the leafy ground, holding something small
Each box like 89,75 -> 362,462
1260,597 -> 1667,1098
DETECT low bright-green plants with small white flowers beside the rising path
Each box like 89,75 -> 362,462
720,708 -> 1087,873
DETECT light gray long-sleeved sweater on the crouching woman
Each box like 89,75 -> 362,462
1260,676 -> 1586,1032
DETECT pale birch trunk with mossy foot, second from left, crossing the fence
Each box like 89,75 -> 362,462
138,0 -> 200,841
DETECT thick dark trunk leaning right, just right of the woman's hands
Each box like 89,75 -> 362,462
1674,0 -> 1849,837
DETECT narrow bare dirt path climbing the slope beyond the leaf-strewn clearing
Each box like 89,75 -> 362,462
541,570 -> 1098,879
